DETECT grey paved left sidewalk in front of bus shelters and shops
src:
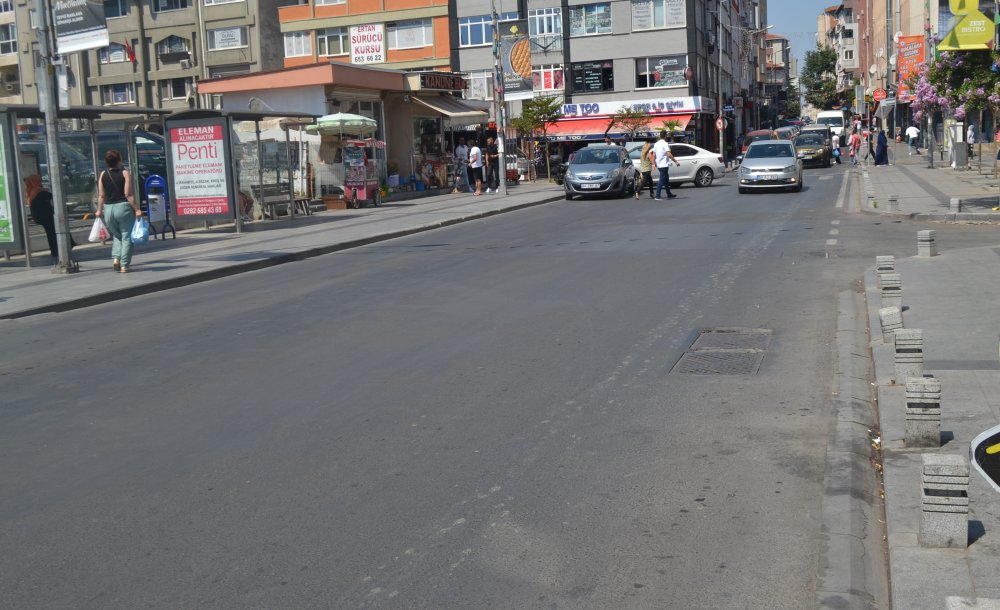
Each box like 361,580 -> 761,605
0,181 -> 563,319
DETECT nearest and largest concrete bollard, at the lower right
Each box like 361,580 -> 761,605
920,453 -> 969,549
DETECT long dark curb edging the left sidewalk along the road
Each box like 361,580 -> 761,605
0,195 -> 563,320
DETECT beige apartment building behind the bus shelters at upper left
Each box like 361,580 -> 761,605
12,0 -> 281,109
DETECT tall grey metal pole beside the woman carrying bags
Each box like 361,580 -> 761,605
31,0 -> 80,273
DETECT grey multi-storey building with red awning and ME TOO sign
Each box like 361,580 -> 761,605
449,0 -> 766,153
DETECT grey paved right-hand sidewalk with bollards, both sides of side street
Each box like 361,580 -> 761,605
858,146 -> 1000,610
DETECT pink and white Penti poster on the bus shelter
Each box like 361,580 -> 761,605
167,117 -> 234,218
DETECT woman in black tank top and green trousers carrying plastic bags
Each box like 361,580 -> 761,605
97,148 -> 142,273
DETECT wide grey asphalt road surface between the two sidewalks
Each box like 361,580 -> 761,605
0,167 -> 994,609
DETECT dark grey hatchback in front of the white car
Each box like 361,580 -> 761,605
563,144 -> 635,199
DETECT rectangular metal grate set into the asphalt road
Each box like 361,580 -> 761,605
672,328 -> 771,375
